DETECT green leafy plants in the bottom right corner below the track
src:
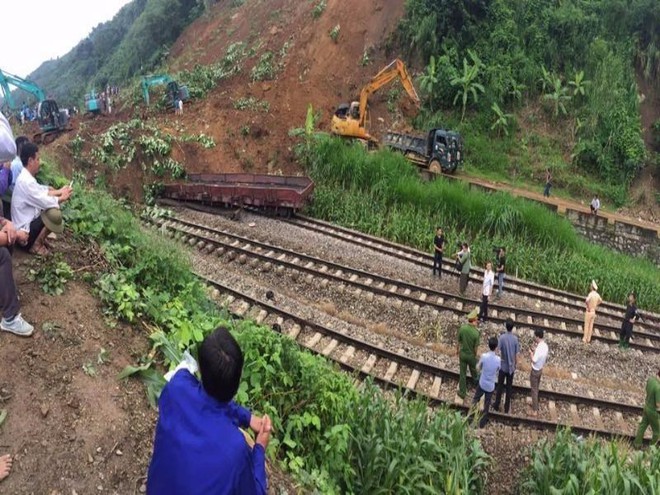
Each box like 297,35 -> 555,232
519,430 -> 660,495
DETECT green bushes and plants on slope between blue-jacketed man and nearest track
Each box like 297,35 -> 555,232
60,176 -> 487,495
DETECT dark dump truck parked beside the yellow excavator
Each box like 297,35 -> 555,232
382,129 -> 463,174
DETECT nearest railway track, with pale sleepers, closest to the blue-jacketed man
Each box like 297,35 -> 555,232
198,275 -> 648,441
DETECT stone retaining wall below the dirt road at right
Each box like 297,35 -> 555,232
566,208 -> 660,266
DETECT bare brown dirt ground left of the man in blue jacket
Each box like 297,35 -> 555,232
0,246 -> 156,495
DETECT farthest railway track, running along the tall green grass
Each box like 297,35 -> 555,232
283,215 -> 660,332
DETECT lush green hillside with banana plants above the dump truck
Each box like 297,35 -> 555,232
397,0 -> 660,204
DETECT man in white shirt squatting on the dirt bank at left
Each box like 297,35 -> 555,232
11,143 -> 73,255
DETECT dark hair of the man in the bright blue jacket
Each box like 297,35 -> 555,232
198,327 -> 243,402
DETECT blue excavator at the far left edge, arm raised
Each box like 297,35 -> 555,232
0,70 -> 71,144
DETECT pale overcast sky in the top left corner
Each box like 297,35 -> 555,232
0,0 -> 131,77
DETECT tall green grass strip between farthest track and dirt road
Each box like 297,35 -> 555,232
300,136 -> 660,311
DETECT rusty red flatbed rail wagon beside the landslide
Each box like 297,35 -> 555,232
162,174 -> 314,215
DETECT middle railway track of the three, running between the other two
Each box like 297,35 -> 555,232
150,217 -> 660,353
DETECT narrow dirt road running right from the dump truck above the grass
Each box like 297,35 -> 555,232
450,173 -> 660,235
